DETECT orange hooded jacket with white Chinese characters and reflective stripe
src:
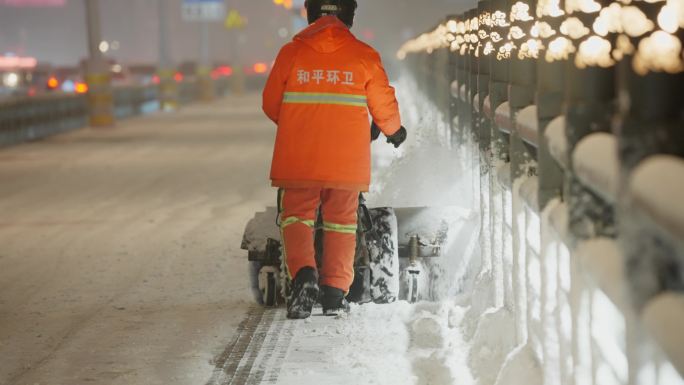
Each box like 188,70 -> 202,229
263,16 -> 401,191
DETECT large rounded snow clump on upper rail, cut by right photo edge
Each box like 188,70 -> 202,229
630,155 -> 684,240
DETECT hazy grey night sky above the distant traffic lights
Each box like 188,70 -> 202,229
0,0 -> 473,65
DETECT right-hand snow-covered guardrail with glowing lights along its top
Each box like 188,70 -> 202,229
399,0 -> 684,385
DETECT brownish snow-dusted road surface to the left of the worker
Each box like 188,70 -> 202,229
0,95 -> 275,385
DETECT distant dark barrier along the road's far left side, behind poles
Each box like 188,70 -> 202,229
0,79 -> 230,147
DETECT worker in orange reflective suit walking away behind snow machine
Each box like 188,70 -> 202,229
263,0 -> 406,319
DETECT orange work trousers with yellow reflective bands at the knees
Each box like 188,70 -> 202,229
280,188 -> 359,292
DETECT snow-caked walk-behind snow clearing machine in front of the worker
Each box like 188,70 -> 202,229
242,195 -> 449,306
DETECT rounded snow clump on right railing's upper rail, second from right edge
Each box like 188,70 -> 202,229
572,132 -> 620,203
